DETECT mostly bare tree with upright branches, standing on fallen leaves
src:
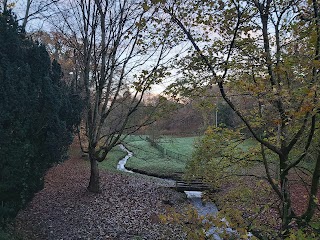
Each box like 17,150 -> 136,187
54,0 -> 169,192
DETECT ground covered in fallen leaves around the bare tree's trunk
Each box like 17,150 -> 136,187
15,142 -> 185,240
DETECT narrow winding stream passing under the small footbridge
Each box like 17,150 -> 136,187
117,144 -> 239,240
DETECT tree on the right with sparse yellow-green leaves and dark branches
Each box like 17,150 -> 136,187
145,0 -> 320,236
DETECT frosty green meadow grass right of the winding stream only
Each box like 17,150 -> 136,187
125,137 -> 194,177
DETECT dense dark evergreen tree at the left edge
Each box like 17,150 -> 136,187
0,11 -> 81,225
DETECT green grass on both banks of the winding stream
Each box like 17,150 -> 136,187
100,136 -> 195,177
